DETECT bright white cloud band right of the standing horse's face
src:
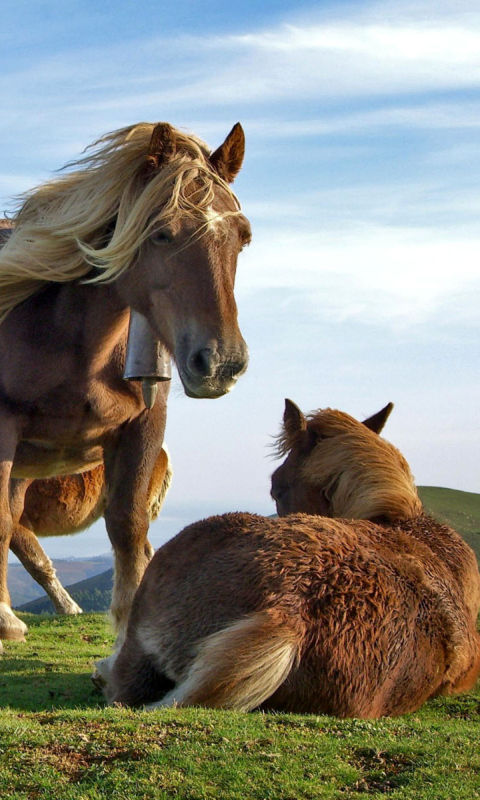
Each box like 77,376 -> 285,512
238,226 -> 480,328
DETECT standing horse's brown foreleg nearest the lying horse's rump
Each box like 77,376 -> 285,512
104,404 -> 165,649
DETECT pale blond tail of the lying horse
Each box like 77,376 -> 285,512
156,610 -> 300,711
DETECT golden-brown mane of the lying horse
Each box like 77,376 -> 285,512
275,408 -> 422,523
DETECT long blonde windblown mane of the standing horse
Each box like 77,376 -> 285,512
0,122 -> 240,322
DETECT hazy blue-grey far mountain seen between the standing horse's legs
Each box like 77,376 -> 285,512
8,554 -> 113,608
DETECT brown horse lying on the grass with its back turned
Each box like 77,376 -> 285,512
99,401 -> 480,717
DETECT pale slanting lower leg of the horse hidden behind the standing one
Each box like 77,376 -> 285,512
10,518 -> 82,614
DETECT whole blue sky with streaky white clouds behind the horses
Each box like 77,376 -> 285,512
0,0 -> 480,556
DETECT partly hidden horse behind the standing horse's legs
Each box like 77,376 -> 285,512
10,447 -> 172,614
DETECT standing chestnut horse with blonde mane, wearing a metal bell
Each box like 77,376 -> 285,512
0,123 -> 250,643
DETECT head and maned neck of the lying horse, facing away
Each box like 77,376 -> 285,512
271,400 -> 421,522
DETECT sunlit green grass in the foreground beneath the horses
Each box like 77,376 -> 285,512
0,614 -> 480,800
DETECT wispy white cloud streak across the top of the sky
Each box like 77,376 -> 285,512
4,3 -> 480,124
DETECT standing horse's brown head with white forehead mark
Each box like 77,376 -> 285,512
112,123 -> 251,397
